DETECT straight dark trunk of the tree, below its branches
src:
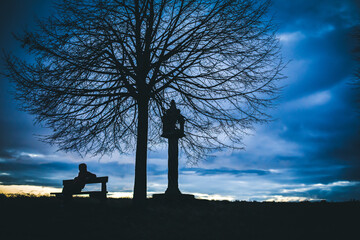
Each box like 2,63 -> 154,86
133,100 -> 149,205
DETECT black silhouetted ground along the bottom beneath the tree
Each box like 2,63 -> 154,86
0,195 -> 360,240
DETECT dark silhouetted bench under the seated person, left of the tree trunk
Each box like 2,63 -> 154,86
50,177 -> 109,200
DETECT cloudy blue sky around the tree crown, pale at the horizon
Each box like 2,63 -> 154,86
0,0 -> 360,201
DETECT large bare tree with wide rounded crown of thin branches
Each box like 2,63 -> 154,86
5,0 -> 283,201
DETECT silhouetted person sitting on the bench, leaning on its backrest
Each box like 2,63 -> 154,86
63,163 -> 96,197
